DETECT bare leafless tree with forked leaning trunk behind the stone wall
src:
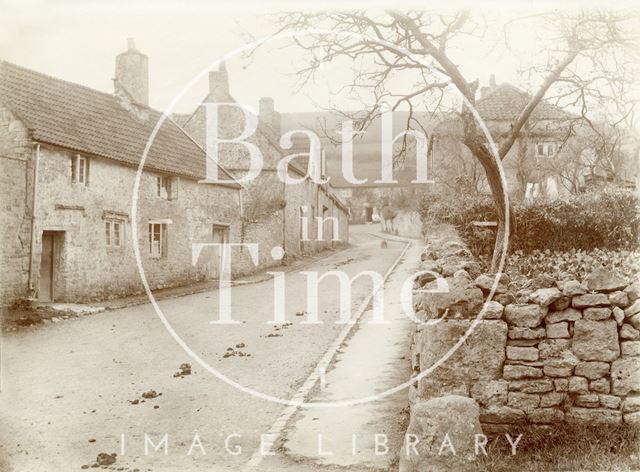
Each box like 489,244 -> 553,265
279,11 -> 637,270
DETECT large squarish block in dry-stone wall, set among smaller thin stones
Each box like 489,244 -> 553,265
571,320 -> 620,361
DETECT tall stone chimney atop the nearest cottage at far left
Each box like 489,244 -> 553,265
114,38 -> 149,106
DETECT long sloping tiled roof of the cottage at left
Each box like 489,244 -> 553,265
0,61 -> 237,185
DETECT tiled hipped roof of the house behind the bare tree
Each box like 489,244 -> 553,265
476,84 -> 572,121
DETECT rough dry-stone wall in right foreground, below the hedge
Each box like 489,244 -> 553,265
410,232 -> 640,430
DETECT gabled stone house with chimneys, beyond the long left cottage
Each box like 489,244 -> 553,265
177,64 -> 349,267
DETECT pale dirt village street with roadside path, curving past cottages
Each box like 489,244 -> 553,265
0,225 -> 419,471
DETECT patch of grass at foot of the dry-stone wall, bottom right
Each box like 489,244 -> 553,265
482,424 -> 640,472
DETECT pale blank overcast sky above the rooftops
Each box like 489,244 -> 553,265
0,0 -> 633,116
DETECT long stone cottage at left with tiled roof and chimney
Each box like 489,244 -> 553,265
0,41 -> 241,306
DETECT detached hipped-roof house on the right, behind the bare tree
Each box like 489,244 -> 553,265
430,75 -> 604,198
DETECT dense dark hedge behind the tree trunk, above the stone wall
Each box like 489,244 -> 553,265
419,188 -> 640,255
